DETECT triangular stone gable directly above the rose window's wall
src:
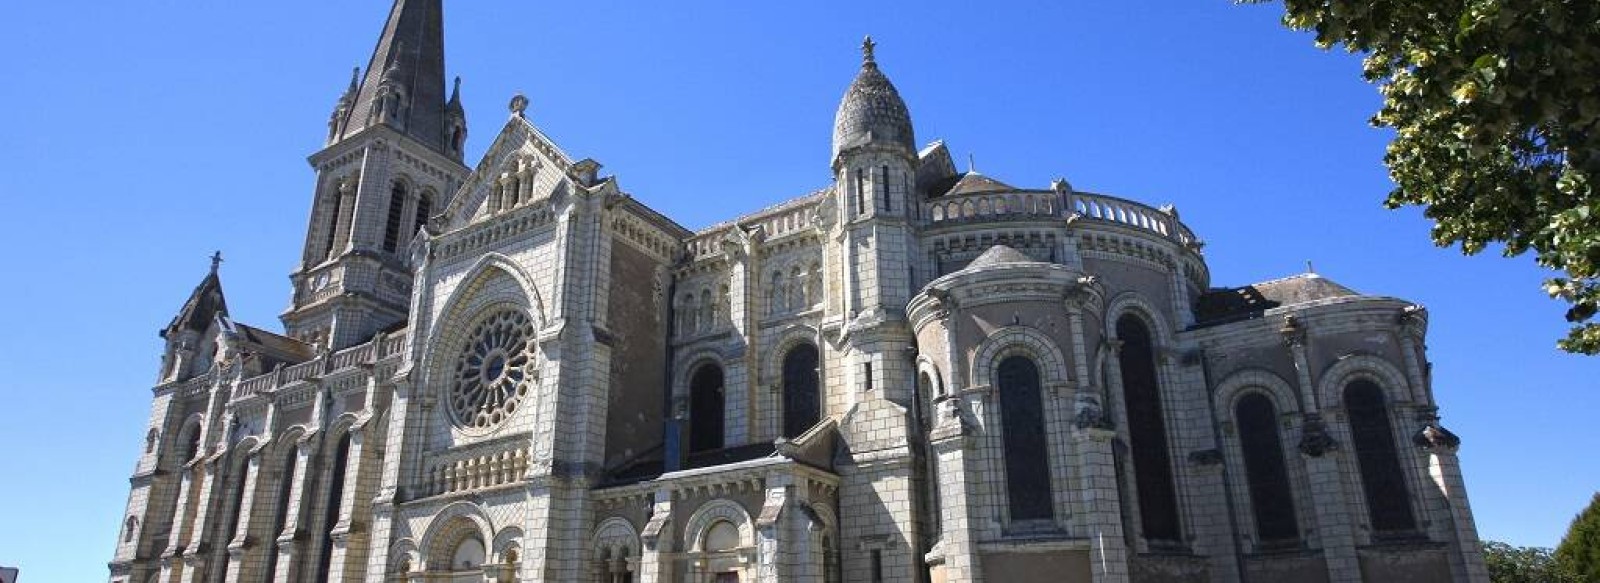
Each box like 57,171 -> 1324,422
445,115 -> 582,232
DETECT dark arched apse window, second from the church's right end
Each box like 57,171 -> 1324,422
1234,392 -> 1299,543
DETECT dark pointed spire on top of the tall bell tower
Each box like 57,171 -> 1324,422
342,0 -> 448,152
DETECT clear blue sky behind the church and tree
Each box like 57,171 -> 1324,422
0,0 -> 1600,581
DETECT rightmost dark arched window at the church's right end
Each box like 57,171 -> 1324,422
1344,380 -> 1416,533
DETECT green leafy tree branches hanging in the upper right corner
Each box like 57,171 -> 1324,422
1240,0 -> 1600,354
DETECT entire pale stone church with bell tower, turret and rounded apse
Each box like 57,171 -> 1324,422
110,0 -> 1486,583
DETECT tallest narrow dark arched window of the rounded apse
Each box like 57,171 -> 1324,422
1117,314 -> 1182,541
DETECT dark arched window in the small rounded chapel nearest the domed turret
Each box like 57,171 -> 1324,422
995,356 -> 1054,521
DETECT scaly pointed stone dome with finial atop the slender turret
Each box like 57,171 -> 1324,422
834,37 -> 917,159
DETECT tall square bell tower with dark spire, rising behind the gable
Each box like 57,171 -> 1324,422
282,0 -> 469,349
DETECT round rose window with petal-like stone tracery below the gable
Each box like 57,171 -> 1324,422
450,311 -> 533,429
